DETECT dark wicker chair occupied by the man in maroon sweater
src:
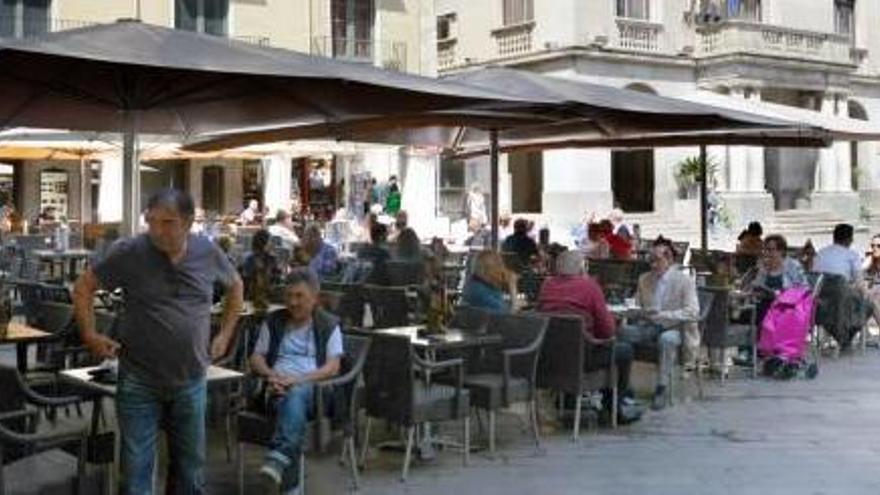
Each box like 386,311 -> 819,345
537,314 -> 619,441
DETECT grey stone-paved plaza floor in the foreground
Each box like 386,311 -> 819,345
1,348 -> 880,495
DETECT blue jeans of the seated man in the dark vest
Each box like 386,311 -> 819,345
266,384 -> 314,470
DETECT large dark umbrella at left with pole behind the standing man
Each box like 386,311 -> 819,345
0,21 -> 536,232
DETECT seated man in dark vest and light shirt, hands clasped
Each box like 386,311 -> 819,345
250,268 -> 343,493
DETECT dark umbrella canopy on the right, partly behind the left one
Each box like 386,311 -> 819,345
187,68 -> 827,151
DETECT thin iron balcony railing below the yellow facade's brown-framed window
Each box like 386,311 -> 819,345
311,36 -> 406,71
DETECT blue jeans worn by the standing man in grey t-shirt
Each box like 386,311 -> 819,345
116,373 -> 207,495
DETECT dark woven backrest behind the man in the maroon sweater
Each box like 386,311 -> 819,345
537,315 -> 585,394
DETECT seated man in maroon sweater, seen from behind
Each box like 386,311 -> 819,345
538,251 -> 638,421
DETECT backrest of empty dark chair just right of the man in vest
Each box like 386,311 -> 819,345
363,333 -> 415,423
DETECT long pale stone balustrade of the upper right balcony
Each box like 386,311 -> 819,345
697,21 -> 855,64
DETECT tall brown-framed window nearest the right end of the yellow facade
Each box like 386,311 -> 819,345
331,0 -> 375,60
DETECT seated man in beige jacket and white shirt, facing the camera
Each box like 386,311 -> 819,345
620,237 -> 700,410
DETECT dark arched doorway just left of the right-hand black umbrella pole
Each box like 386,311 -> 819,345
611,83 -> 657,212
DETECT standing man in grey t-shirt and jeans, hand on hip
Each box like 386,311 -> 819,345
74,189 -> 243,495
